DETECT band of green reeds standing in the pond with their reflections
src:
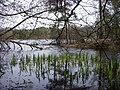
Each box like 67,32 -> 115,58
10,53 -> 120,90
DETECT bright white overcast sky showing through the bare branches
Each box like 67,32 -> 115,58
0,0 -> 98,29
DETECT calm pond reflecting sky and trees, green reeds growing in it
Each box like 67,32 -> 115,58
0,40 -> 120,90
